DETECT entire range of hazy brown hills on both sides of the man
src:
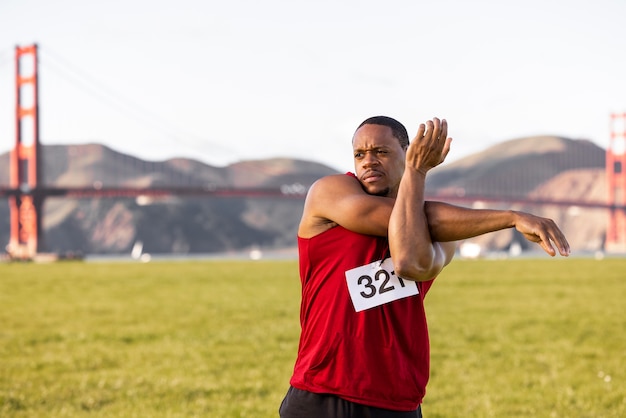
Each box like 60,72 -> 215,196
0,136 -> 606,254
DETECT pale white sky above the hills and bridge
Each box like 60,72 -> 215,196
0,0 -> 626,171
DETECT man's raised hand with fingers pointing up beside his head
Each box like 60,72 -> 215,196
406,118 -> 452,175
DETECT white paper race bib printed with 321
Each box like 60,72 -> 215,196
346,258 -> 419,312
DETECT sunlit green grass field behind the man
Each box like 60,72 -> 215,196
0,256 -> 626,418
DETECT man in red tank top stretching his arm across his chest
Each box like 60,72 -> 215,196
280,116 -> 569,418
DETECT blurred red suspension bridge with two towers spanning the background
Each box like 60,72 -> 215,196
0,44 -> 626,260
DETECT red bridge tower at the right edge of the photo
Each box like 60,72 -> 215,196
605,113 -> 626,253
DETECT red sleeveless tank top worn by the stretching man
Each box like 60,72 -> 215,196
290,226 -> 432,411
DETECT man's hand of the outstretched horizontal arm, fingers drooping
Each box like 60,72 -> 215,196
514,212 -> 570,257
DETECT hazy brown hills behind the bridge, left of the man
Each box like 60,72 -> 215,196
0,144 -> 335,254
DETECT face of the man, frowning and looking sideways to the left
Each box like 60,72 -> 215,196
352,125 -> 406,197
